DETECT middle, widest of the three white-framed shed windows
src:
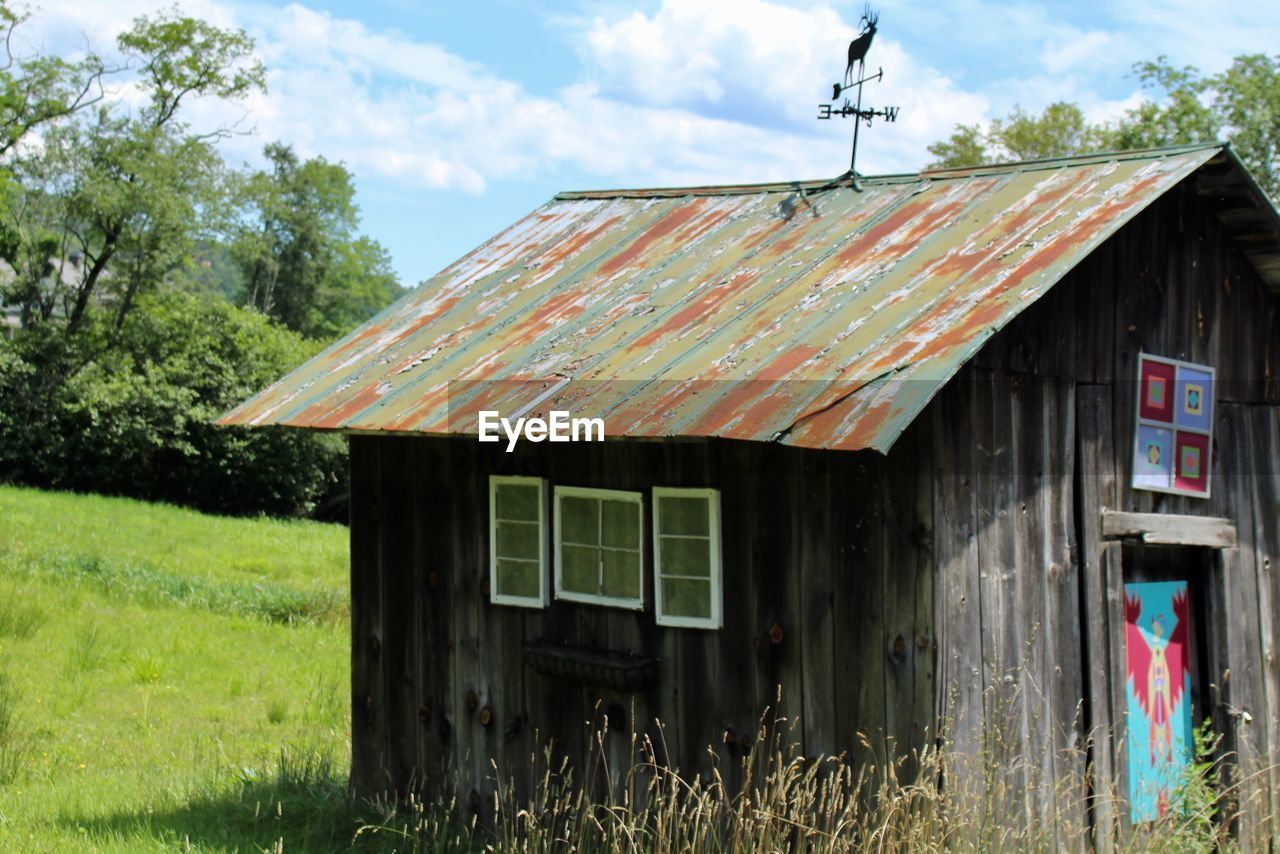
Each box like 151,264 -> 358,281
556,487 -> 644,611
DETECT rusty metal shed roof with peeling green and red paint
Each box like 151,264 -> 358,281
221,146 -> 1222,452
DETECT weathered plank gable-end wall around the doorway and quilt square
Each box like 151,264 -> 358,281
952,179 -> 1280,848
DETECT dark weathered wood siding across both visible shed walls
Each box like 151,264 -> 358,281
351,181 -> 1280,846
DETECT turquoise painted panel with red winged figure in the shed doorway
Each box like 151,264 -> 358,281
1124,581 -> 1193,822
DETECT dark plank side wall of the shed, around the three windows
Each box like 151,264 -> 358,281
351,425 -> 936,813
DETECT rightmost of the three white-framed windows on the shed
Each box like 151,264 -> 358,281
653,487 -> 723,629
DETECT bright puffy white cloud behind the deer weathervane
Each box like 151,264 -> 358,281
582,0 -> 988,171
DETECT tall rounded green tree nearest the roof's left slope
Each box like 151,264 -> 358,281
232,142 -> 402,338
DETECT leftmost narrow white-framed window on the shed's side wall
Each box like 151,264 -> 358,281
489,475 -> 547,608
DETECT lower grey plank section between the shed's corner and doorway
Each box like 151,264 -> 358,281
933,367 -> 1085,841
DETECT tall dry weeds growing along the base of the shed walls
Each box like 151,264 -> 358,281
357,686 -> 1263,854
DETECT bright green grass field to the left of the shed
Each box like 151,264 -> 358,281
0,487 -> 372,851
